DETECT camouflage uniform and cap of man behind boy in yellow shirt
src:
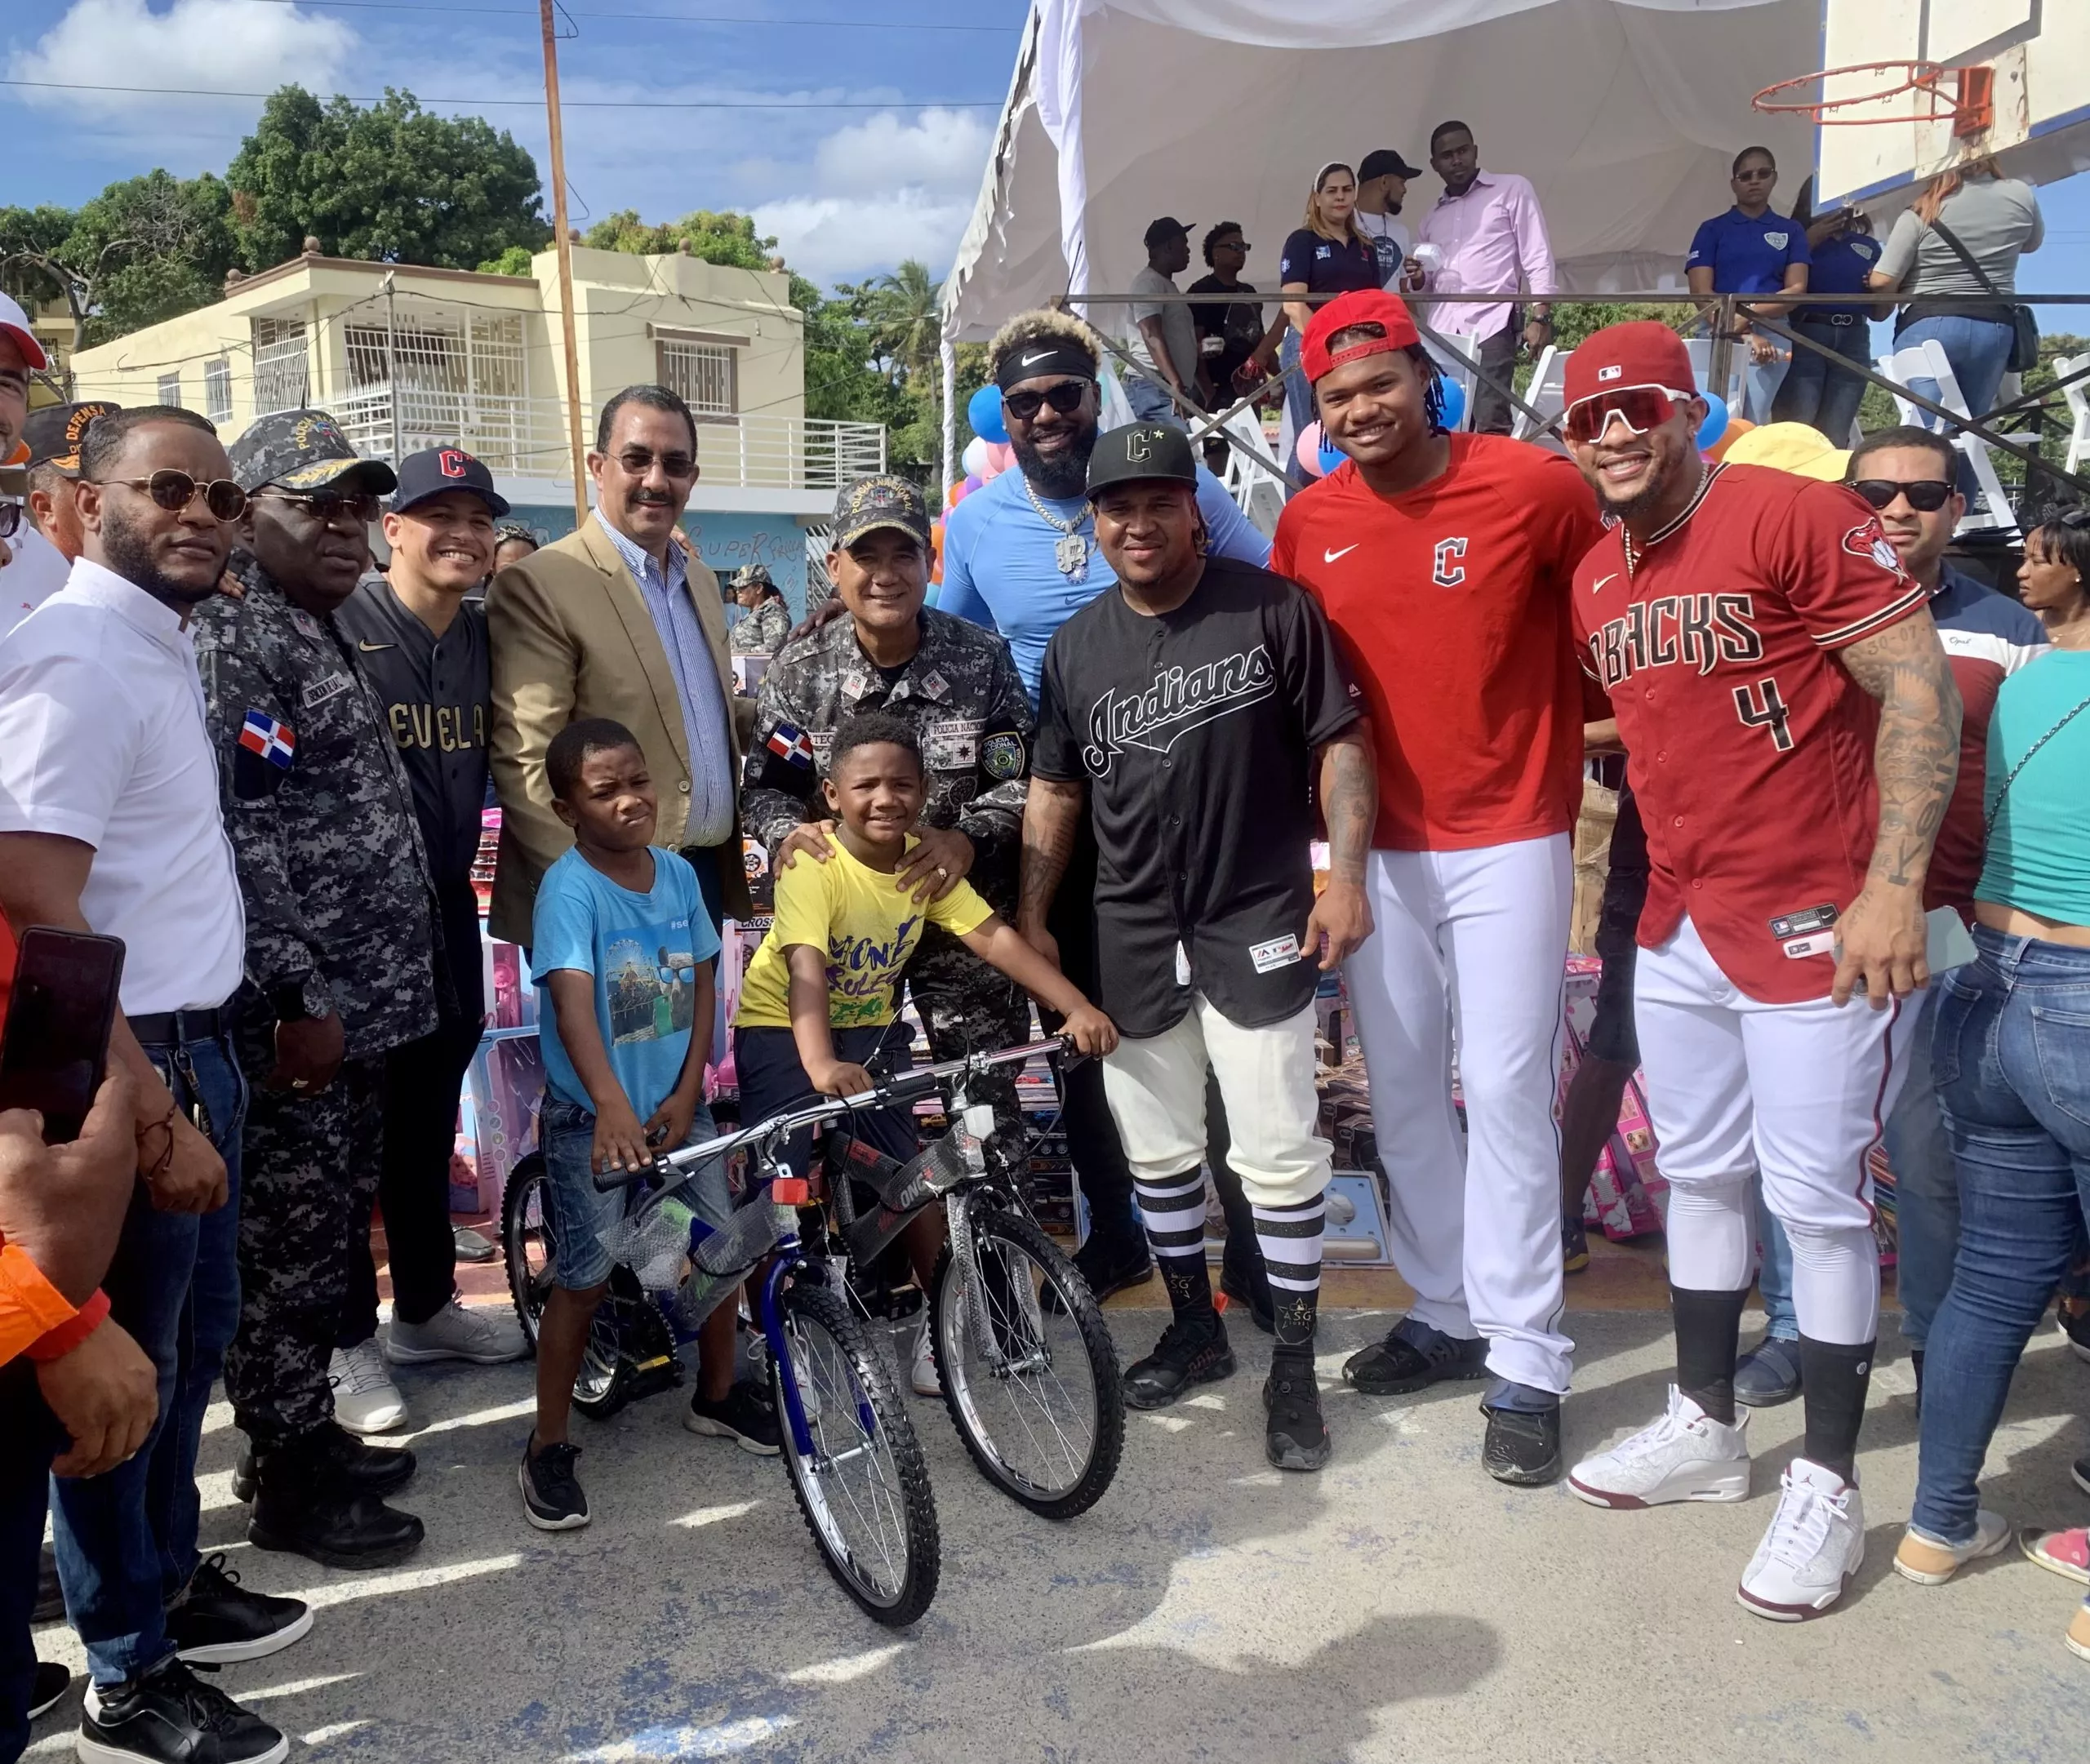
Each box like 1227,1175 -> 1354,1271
740,478 -> 1034,1171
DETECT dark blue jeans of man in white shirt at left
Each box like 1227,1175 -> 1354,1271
50,1037 -> 247,1685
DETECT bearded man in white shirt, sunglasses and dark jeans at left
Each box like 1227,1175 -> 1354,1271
0,406 -> 311,1764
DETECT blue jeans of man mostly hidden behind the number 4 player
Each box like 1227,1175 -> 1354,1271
1755,984 -> 1959,1345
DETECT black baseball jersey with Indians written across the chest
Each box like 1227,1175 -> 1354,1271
1033,558 -> 1363,1034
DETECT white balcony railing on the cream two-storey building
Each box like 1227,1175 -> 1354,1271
315,384 -> 886,489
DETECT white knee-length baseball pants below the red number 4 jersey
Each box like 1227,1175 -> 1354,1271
1632,920 -> 1921,1346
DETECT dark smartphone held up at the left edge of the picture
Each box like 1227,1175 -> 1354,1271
0,926 -> 123,1145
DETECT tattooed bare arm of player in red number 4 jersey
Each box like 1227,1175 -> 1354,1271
1831,611 -> 1960,1010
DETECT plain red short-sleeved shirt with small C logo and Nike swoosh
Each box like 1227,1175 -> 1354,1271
1270,435 -> 1603,851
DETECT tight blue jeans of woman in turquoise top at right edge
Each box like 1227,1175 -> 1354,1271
1910,926 -> 2090,1543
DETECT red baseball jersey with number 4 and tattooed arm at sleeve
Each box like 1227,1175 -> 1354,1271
1574,466 -> 1925,1003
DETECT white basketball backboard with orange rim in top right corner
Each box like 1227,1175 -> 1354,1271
1805,0 -> 2090,213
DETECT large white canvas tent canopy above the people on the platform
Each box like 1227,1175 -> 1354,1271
945,0 -> 1821,340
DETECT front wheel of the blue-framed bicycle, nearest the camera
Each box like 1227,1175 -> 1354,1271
769,1282 -> 943,1628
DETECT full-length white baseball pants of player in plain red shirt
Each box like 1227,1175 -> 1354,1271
1344,834 -> 1574,1394
